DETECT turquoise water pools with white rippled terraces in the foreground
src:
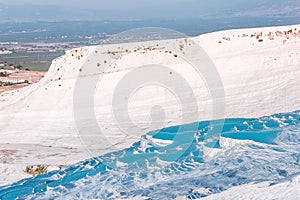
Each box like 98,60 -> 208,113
0,111 -> 300,199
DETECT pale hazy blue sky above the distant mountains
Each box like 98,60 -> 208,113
0,0 -> 300,19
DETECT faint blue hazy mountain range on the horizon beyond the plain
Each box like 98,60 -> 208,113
0,0 -> 300,22
